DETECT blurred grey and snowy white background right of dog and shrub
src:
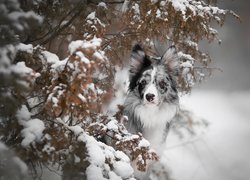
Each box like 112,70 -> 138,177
163,0 -> 250,180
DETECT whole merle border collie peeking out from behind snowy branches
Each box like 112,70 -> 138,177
124,45 -> 179,155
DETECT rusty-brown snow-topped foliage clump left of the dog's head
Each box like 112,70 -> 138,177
43,37 -> 107,113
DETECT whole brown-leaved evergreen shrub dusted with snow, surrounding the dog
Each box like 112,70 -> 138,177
0,0 -> 237,180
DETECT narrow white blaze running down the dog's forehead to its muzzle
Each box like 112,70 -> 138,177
144,67 -> 159,104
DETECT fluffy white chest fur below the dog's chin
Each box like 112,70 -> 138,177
136,104 -> 178,153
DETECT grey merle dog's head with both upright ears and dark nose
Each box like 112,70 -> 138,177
129,45 -> 179,106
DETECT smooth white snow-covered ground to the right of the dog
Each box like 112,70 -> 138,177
163,90 -> 250,180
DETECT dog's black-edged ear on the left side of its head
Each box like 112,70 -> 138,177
129,44 -> 151,77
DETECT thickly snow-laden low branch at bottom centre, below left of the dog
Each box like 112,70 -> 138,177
68,126 -> 133,179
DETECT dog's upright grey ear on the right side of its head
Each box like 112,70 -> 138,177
161,46 -> 179,76
